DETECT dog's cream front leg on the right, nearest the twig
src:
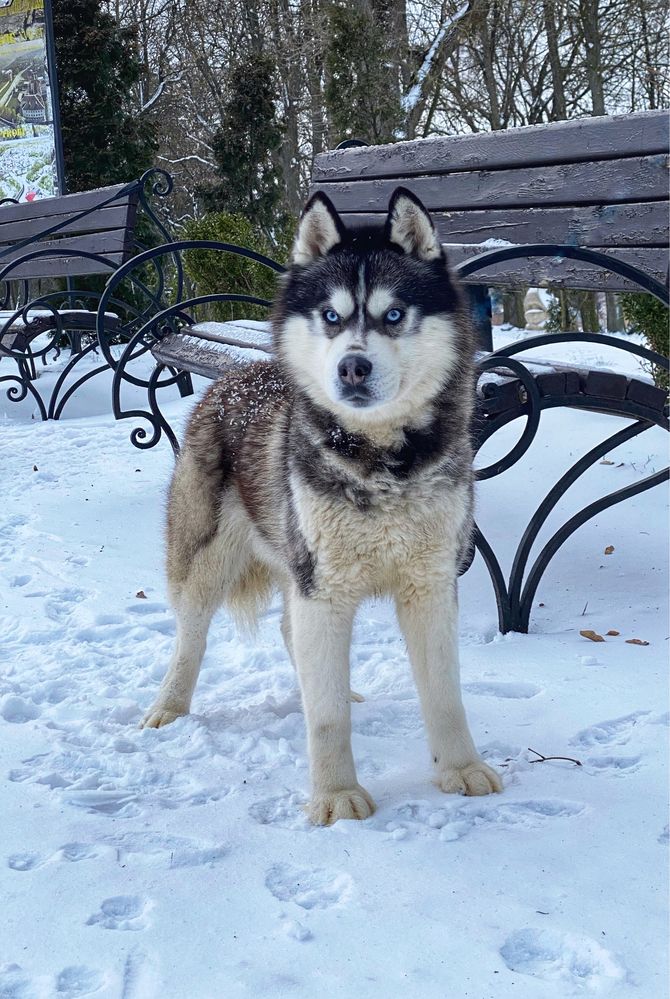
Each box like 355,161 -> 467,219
396,574 -> 502,795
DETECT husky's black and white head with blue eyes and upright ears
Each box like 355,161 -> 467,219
274,188 -> 468,429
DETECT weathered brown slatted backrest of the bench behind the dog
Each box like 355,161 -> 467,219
312,111 -> 669,290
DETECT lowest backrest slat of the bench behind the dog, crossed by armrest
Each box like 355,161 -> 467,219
445,244 -> 668,291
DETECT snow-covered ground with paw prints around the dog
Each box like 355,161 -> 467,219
0,336 -> 669,999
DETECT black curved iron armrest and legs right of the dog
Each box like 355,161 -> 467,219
456,244 -> 670,632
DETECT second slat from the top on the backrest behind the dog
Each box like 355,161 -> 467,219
313,154 -> 668,214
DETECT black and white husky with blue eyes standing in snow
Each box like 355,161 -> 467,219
143,188 -> 501,824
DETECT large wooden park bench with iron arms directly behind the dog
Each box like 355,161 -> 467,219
101,112 -> 668,632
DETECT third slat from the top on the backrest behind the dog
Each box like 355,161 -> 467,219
343,201 -> 670,249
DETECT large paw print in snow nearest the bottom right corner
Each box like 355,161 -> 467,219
500,927 -> 626,993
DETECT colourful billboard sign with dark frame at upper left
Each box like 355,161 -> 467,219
0,0 -> 59,201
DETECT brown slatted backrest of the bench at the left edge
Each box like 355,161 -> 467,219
0,184 -> 138,280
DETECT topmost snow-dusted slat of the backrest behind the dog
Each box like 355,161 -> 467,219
312,111 -> 669,187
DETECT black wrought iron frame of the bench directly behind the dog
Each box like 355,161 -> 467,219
98,234 -> 670,632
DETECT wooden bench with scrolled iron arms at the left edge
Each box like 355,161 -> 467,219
0,175 -> 173,419
